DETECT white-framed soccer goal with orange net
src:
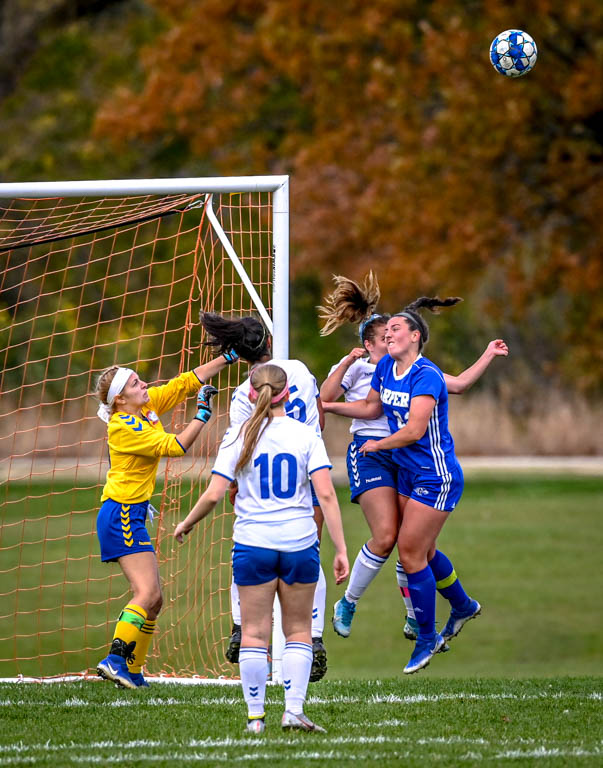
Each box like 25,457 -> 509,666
0,177 -> 288,677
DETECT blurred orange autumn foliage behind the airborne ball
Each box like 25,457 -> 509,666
96,0 -> 603,386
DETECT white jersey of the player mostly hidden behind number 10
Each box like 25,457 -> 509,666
230,360 -> 320,435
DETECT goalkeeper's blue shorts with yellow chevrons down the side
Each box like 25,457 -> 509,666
96,499 -> 155,563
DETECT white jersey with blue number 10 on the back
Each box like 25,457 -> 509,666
212,416 -> 331,552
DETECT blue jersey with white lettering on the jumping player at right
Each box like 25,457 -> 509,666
371,355 -> 458,476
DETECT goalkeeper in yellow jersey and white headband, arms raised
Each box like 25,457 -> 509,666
96,352 -> 237,688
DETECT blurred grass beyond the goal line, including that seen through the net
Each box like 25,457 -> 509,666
0,475 -> 603,679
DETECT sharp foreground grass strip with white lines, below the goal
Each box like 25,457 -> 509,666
0,675 -> 603,768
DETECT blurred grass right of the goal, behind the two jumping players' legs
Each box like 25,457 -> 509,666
321,475 -> 603,678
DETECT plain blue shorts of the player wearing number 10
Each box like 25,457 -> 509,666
232,540 -> 320,587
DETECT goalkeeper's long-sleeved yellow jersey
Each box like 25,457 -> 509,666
101,371 -> 203,504
